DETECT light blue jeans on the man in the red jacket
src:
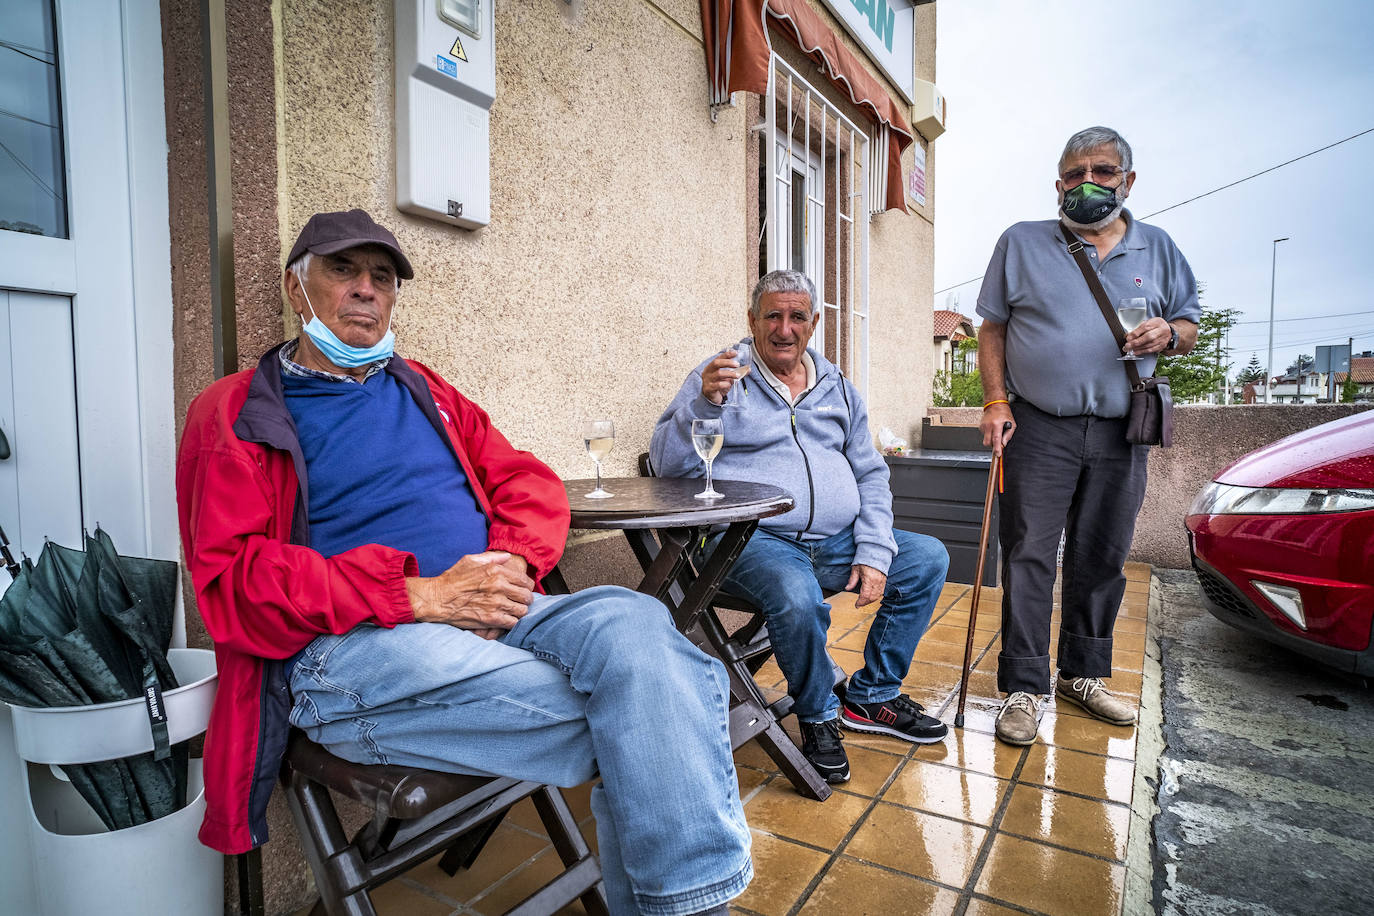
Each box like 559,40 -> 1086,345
291,586 -> 753,916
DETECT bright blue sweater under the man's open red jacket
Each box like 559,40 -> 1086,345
282,372 -> 488,575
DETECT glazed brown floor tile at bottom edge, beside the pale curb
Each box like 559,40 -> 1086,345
976,834 -> 1125,916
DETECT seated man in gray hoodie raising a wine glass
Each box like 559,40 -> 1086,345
650,271 -> 949,783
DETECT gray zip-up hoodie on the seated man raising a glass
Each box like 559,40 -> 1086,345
649,347 -> 897,574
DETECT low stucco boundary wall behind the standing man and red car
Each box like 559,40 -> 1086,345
930,404 -> 1370,569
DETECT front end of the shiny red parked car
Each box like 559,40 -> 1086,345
1187,411 -> 1374,676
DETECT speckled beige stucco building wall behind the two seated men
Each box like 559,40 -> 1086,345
279,0 -> 933,477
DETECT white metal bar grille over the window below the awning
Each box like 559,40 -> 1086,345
760,55 -> 868,397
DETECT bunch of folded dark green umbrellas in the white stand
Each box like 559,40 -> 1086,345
0,529 -> 188,829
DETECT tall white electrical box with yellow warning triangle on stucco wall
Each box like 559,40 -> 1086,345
396,0 -> 496,229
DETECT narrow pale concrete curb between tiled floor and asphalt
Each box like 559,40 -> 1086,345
1121,571 -> 1165,916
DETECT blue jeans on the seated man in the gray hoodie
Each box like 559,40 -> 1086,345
708,526 -> 949,722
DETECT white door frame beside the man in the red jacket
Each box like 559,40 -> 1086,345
0,0 -> 180,560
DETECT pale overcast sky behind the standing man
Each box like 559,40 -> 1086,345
934,0 -> 1374,384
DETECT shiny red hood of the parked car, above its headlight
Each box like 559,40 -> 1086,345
1216,411 -> 1374,488
